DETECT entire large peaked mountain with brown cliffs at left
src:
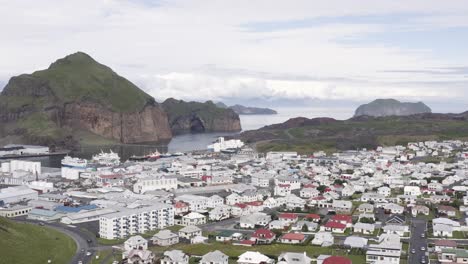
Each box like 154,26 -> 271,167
0,53 -> 172,145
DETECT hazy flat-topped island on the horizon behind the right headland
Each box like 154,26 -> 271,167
354,99 -> 432,117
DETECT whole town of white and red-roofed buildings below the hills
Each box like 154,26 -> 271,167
0,139 -> 468,264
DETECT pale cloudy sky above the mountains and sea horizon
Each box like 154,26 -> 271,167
0,0 -> 468,115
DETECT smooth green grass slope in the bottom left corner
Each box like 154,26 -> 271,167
0,217 -> 76,263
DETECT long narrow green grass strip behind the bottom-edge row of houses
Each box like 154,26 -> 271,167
151,242 -> 365,263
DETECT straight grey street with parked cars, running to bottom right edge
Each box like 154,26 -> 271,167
408,219 -> 429,263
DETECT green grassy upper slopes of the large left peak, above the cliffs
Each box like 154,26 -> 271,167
0,52 -> 154,112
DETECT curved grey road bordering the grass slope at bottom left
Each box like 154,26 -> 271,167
15,218 -> 111,264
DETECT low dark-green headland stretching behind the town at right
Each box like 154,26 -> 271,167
241,114 -> 468,154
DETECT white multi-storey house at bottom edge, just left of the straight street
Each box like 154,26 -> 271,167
366,234 -> 402,264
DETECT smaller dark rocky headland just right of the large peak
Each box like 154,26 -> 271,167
162,98 -> 241,134
